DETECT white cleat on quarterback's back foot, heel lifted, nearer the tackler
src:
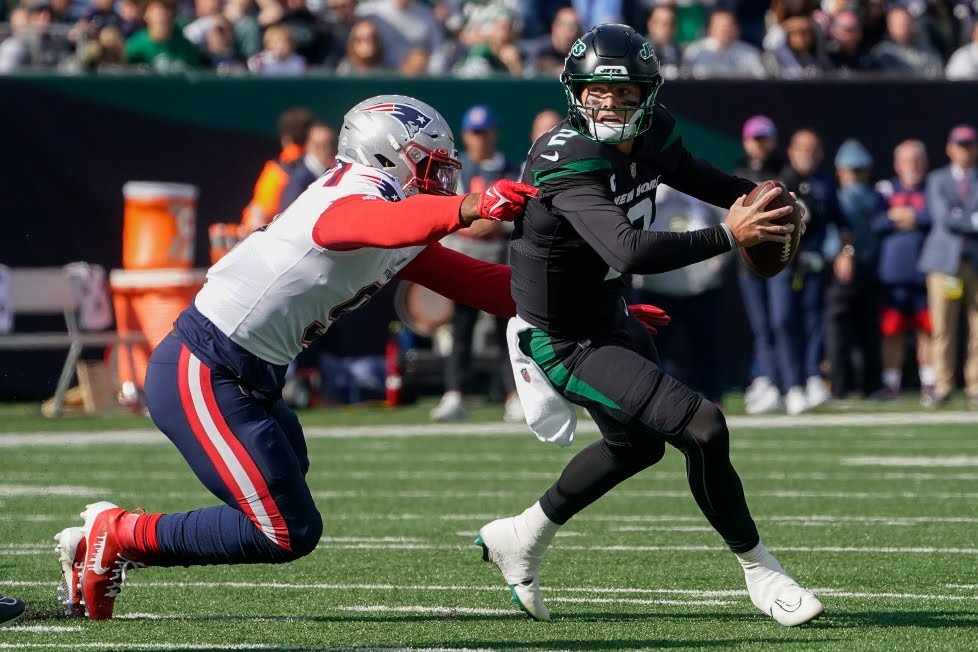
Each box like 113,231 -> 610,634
475,516 -> 550,621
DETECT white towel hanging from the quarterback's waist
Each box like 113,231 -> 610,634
506,316 -> 577,448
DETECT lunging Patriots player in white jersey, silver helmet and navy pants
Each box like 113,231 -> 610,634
55,95 -> 536,620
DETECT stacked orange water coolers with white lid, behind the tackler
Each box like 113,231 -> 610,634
109,181 -> 206,402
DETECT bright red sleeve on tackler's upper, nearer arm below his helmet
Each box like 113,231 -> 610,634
312,195 -> 465,251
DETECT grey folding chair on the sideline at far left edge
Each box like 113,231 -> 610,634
0,267 -> 146,416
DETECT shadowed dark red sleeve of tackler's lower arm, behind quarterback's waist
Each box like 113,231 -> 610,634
396,242 -> 516,317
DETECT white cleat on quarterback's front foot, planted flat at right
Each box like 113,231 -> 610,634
738,544 -> 824,627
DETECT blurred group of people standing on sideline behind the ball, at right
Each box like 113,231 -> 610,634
635,116 -> 978,414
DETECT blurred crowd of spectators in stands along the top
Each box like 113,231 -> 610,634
0,0 -> 978,80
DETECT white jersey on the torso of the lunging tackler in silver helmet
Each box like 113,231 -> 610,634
194,163 -> 424,364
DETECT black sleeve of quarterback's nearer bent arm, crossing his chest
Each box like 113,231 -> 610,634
551,175 -> 733,274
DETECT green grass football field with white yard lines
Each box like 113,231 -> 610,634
0,406 -> 978,652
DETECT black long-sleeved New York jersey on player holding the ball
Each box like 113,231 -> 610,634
510,105 -> 754,338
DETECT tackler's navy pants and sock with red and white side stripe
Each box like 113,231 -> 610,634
146,334 -> 323,566
